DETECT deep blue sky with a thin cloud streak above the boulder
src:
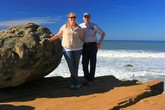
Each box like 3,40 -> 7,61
0,0 -> 165,41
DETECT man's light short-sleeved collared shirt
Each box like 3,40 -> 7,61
80,22 -> 104,42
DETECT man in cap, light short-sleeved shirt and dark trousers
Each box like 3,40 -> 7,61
80,13 -> 105,86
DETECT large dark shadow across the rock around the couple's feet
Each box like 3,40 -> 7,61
0,76 -> 137,103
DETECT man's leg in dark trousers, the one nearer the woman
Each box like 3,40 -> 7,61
82,45 -> 89,81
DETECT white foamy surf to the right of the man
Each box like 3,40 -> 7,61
97,50 -> 165,78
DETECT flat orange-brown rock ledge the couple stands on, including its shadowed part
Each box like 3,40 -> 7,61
0,76 -> 165,110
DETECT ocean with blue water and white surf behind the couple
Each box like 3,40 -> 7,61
46,40 -> 165,91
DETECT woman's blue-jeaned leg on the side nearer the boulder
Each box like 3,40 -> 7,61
64,51 -> 80,86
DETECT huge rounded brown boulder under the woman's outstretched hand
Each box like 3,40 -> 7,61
0,23 -> 62,88
